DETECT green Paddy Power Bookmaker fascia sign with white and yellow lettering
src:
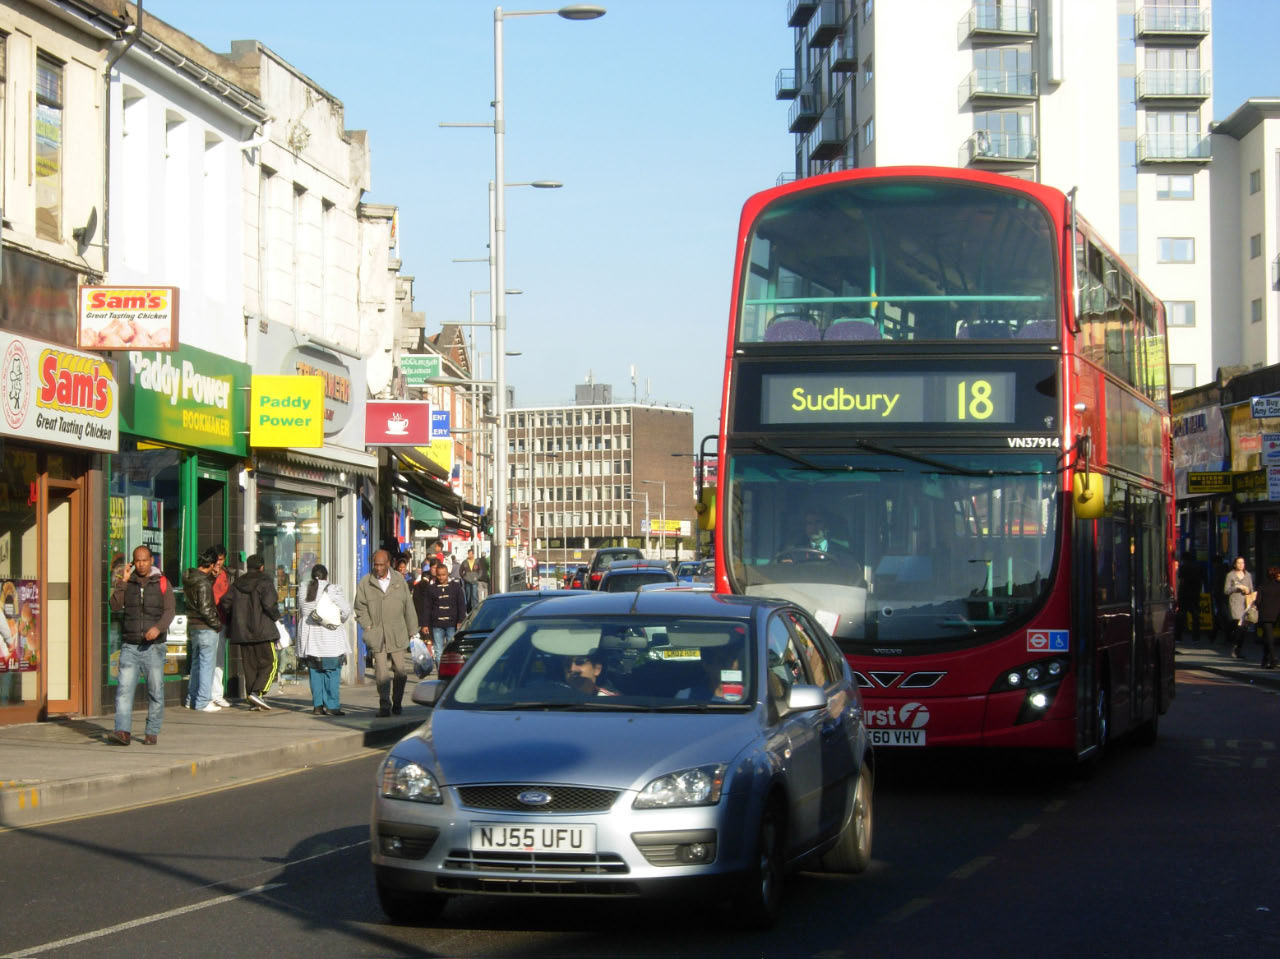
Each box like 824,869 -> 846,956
120,346 -> 250,456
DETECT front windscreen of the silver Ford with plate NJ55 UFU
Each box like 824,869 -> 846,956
442,616 -> 755,712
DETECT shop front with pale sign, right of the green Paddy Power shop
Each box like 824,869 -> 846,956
246,321 -> 378,682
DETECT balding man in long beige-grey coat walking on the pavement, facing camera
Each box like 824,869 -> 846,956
353,549 -> 417,716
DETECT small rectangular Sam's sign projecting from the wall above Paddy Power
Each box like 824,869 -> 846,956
77,287 -> 179,352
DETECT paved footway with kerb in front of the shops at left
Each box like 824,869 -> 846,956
0,676 -> 428,831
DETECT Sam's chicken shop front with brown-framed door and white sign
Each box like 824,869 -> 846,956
0,325 -> 119,725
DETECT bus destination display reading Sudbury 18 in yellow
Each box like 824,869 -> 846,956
760,373 -> 1016,426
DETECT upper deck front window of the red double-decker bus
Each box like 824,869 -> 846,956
739,179 -> 1060,343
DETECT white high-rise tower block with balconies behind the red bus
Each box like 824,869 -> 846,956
774,0 -> 1213,389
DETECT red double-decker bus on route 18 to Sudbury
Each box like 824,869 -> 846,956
704,168 -> 1174,761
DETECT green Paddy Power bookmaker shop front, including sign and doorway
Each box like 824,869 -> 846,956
110,344 -> 250,702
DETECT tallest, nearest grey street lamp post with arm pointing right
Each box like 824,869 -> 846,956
489,4 -> 604,593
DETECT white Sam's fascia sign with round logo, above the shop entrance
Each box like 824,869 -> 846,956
0,330 -> 120,453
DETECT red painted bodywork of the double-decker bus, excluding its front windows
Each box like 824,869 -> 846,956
714,166 -> 1175,758
